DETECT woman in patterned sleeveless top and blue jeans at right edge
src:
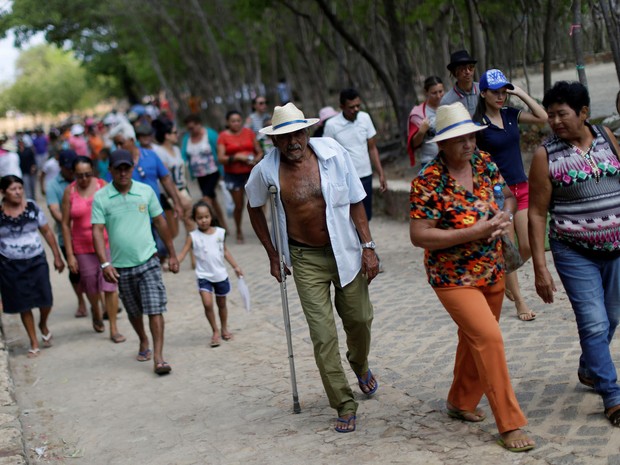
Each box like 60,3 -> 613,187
528,81 -> 620,426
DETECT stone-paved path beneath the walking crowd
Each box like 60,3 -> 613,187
0,197 -> 620,465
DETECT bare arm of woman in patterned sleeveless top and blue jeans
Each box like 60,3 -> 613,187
527,147 -> 556,304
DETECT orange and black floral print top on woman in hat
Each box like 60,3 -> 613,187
410,152 -> 504,287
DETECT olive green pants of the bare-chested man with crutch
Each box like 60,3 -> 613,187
290,246 -> 373,416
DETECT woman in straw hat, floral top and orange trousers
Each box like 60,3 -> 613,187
410,103 -> 534,452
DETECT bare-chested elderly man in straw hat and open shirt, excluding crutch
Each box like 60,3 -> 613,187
246,103 -> 379,433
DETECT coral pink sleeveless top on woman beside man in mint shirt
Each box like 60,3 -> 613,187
69,179 -> 109,255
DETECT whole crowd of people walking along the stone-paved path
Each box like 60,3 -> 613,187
0,50 -> 620,452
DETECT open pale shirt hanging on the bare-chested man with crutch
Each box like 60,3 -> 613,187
245,137 -> 366,286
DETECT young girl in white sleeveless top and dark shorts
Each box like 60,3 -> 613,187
178,200 -> 243,347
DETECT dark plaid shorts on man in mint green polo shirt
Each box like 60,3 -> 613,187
117,256 -> 168,318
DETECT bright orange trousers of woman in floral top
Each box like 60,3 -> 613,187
433,280 -> 527,433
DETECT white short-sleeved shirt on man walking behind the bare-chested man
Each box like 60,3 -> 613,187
323,111 -> 377,178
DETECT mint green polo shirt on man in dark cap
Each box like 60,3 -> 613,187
91,181 -> 163,268
